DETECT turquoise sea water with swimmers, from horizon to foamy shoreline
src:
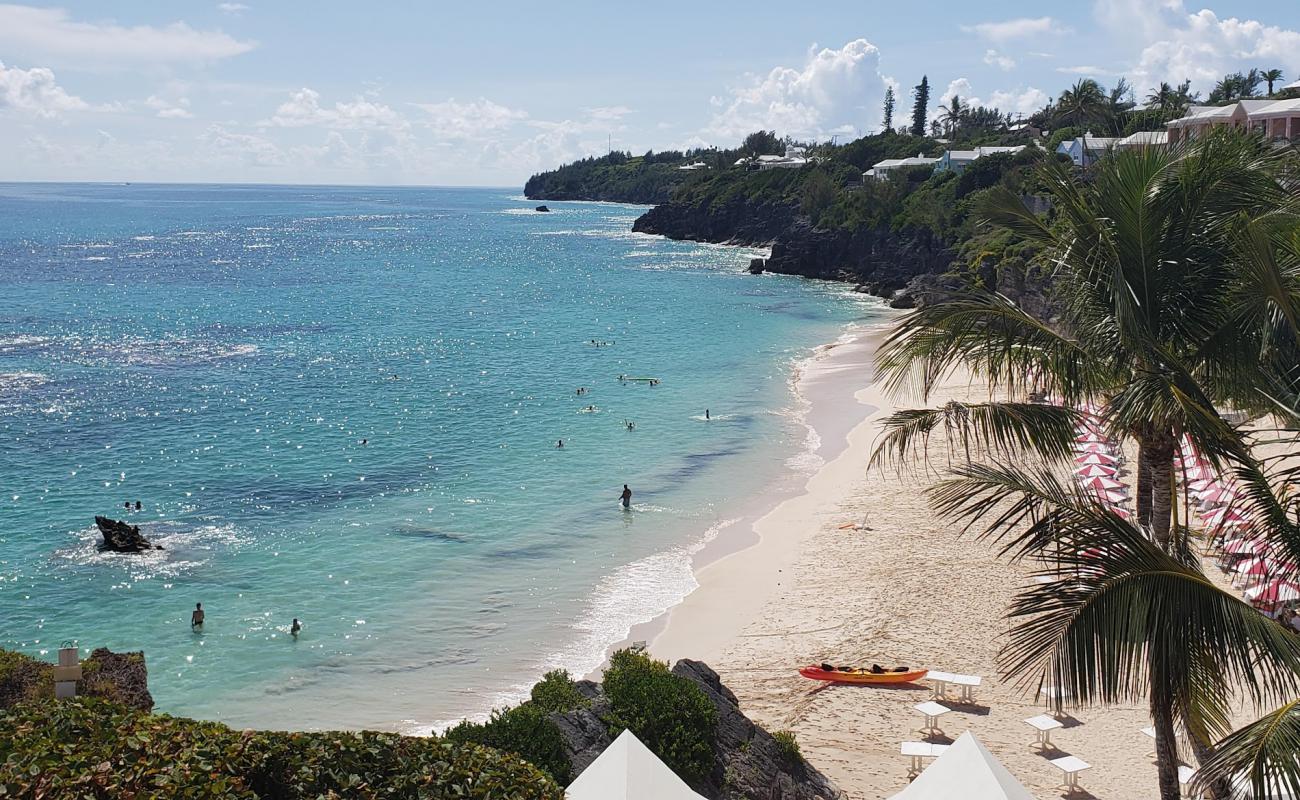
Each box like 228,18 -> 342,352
0,185 -> 870,728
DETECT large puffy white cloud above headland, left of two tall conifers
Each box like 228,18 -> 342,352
706,39 -> 885,140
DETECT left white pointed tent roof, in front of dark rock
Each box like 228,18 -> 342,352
564,731 -> 705,800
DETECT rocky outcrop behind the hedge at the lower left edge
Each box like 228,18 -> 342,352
0,648 -> 153,712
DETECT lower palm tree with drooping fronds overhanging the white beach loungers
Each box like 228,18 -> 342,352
932,464 -> 1300,800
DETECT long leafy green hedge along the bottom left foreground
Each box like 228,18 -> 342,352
0,699 -> 563,800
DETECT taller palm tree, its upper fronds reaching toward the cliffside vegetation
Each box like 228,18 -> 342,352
875,134 -> 1300,546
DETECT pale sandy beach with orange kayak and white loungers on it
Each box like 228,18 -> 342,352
639,321 -> 1180,800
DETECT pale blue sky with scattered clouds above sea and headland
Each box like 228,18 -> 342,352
0,0 -> 1300,186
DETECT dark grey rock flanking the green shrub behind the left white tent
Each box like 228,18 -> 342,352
551,660 -> 841,800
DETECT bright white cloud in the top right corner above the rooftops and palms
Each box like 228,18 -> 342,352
1093,0 -> 1300,90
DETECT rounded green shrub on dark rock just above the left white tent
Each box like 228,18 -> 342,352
603,650 -> 718,780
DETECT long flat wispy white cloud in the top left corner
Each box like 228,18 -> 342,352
0,4 -> 254,65
